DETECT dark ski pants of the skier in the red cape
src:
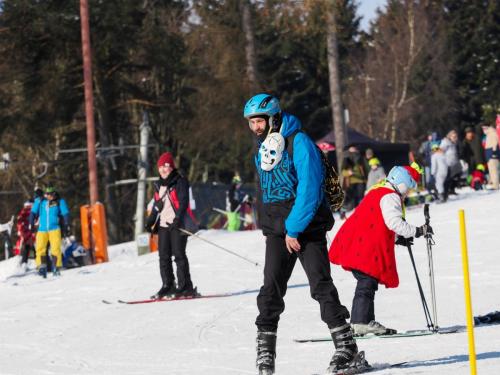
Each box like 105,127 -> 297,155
351,270 -> 378,324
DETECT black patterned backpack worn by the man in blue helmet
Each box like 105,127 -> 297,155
286,130 -> 345,212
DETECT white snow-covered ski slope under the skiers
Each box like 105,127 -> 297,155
0,192 -> 500,375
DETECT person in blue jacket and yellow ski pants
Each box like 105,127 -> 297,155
30,186 -> 70,277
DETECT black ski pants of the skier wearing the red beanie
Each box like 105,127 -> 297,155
158,227 -> 193,290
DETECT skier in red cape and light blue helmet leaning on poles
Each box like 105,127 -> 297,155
329,163 -> 432,335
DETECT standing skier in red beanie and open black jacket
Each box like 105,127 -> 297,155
146,152 -> 197,299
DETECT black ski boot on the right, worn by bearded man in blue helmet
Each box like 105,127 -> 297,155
326,323 -> 370,375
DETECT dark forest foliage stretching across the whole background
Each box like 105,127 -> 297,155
0,0 -> 500,242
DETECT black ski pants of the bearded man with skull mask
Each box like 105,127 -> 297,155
255,233 -> 349,331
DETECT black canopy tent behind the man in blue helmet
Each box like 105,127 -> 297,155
316,127 -> 410,172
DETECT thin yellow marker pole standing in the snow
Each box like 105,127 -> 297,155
458,210 -> 477,375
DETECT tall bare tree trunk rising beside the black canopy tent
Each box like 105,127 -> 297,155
326,0 -> 347,170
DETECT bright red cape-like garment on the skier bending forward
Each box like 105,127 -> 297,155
328,187 -> 399,288
